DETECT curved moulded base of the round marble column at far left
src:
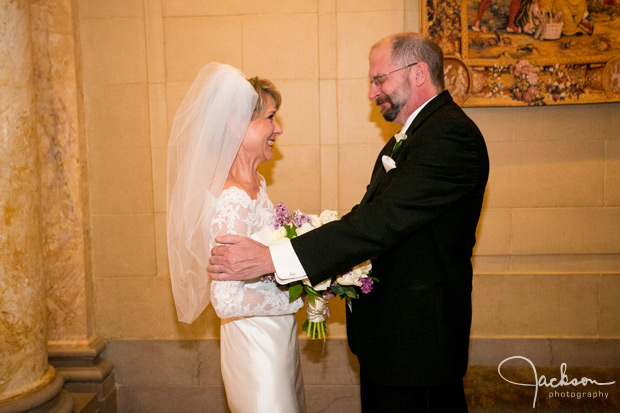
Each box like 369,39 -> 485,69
0,366 -> 73,413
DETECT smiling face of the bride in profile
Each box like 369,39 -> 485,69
240,96 -> 282,162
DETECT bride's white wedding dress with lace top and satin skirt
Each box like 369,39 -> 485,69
211,180 -> 306,413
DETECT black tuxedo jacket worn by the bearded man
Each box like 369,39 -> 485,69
292,91 -> 489,386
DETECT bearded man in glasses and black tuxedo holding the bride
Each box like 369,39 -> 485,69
208,33 -> 489,412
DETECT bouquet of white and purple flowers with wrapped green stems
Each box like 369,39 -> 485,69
273,202 -> 378,339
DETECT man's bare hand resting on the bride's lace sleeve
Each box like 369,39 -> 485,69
207,235 -> 275,281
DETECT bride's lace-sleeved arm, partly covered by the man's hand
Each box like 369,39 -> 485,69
211,194 -> 303,318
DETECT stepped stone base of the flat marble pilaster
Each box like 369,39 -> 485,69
48,339 -> 117,413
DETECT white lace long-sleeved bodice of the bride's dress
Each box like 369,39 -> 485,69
211,180 -> 303,318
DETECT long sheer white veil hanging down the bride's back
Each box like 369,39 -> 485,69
166,63 -> 258,323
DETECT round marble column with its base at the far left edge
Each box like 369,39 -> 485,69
0,0 -> 73,412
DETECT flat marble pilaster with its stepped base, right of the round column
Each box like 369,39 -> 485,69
29,0 -> 116,412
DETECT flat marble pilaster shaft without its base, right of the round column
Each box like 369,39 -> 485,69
29,0 -> 93,347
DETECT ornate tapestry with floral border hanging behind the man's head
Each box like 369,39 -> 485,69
421,0 -> 620,107
